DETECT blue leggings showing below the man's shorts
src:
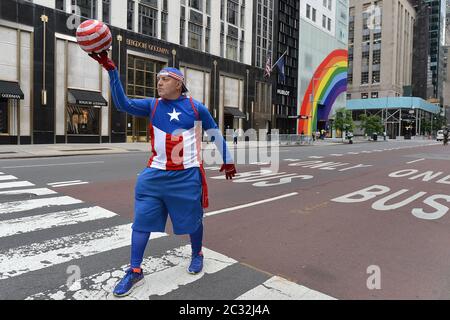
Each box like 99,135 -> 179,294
131,223 -> 203,268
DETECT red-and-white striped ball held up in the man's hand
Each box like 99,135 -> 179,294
77,20 -> 112,53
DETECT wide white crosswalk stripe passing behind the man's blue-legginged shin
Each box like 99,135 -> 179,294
0,224 -> 167,280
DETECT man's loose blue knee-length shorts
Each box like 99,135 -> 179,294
132,168 -> 203,235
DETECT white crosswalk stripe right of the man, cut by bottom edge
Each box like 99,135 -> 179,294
236,277 -> 335,300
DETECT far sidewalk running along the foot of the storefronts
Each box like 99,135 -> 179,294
0,139 -> 367,159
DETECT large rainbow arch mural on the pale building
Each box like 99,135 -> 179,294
297,50 -> 348,135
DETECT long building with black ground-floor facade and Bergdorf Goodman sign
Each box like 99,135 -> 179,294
0,0 -> 271,144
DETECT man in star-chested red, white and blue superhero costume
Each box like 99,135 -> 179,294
90,51 -> 236,297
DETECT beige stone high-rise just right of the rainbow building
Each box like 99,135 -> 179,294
348,0 -> 416,99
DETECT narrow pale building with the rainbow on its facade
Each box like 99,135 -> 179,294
297,0 -> 349,135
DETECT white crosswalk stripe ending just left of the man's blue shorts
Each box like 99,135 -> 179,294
0,207 -> 116,238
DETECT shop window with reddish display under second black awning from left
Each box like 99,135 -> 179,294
67,105 -> 100,135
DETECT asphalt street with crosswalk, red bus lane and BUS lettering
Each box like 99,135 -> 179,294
0,140 -> 450,300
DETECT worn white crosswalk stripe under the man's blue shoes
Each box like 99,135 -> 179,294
27,245 -> 237,300
